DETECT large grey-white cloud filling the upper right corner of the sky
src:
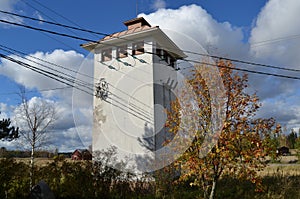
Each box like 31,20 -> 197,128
250,0 -> 300,66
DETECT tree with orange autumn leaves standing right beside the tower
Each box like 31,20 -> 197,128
166,60 -> 280,199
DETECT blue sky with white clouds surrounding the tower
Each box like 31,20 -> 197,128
0,0 -> 300,151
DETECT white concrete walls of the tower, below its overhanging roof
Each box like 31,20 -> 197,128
93,38 -> 176,173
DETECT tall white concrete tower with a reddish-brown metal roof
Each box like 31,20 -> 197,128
82,18 -> 186,171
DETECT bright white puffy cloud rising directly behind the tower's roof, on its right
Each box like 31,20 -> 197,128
139,5 -> 247,57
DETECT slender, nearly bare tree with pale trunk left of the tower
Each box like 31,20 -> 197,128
15,89 -> 57,189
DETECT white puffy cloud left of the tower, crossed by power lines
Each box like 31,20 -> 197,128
0,49 -> 93,103
